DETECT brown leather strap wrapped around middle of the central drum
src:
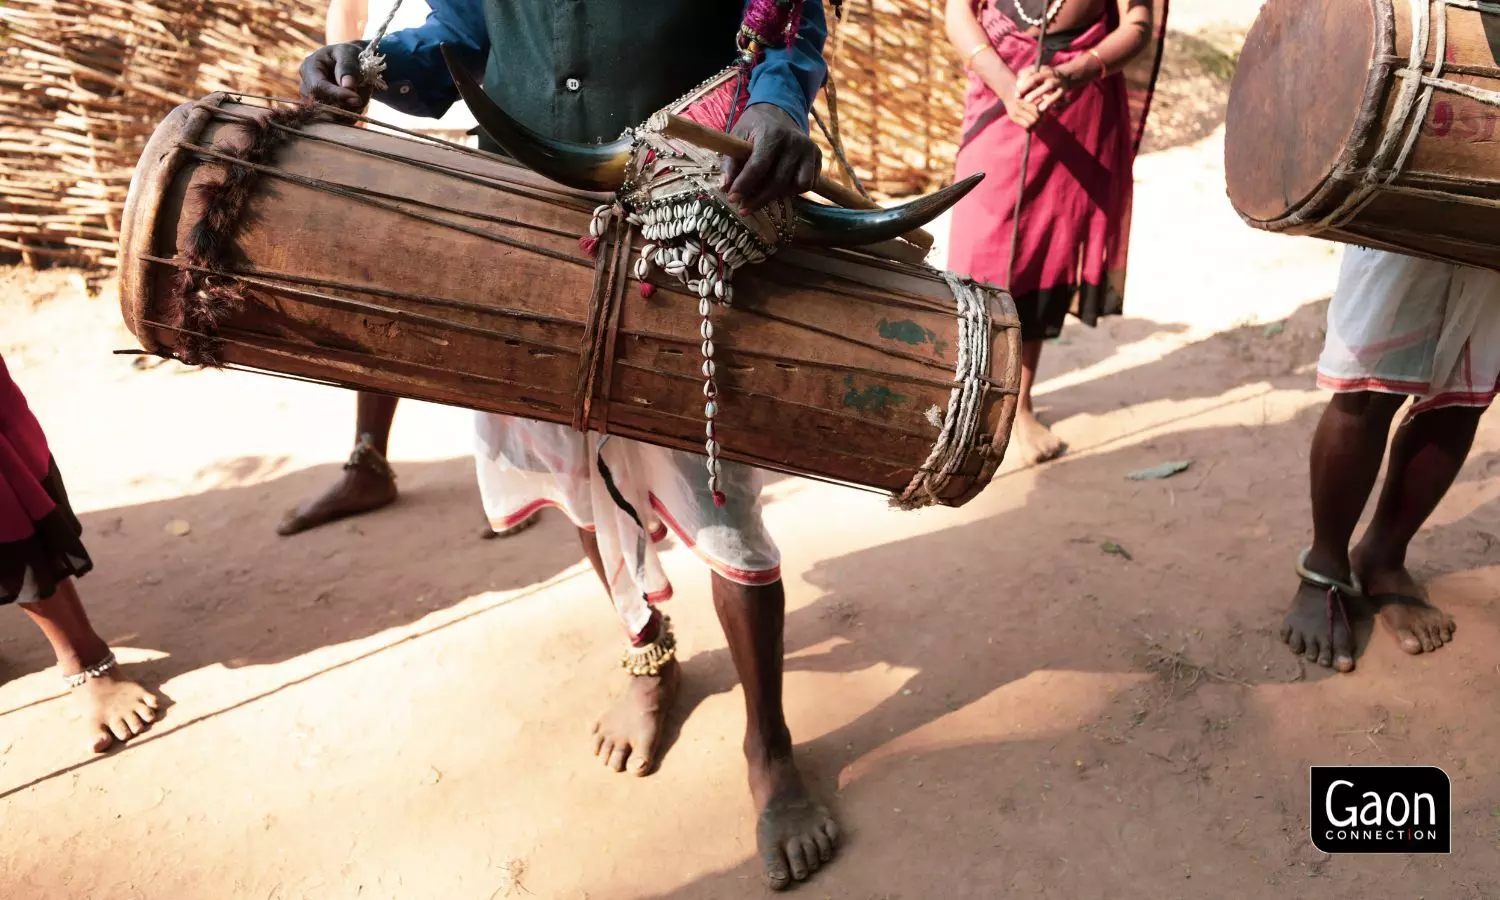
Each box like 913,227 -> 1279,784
573,216 -> 630,432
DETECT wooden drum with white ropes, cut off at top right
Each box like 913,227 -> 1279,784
1224,0 -> 1500,269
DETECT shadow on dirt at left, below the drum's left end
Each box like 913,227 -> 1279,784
0,459 -> 582,681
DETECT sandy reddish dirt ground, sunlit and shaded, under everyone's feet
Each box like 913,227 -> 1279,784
0,3 -> 1500,900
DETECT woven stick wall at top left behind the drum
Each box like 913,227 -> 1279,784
0,0 -> 327,266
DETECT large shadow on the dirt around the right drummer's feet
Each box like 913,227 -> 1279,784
636,303 -> 1500,900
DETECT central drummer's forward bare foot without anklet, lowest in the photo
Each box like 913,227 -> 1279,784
746,752 -> 839,891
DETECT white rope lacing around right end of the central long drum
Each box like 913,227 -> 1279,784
891,272 -> 990,510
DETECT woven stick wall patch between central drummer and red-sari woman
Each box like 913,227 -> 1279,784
813,0 -> 968,197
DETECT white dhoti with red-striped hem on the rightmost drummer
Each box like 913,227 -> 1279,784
1317,248 -> 1500,414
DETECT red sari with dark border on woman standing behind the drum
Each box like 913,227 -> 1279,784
948,0 -> 1167,341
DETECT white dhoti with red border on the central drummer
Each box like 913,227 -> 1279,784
474,413 -> 782,641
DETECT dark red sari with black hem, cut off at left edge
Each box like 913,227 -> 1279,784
0,357 -> 93,605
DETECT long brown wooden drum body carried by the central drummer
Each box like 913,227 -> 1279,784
122,95 -> 1020,506
